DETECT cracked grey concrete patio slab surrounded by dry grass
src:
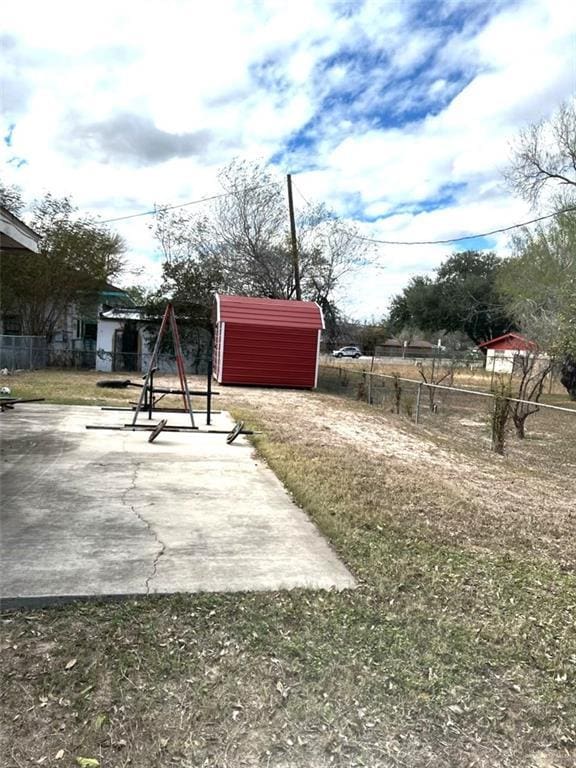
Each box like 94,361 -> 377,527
0,404 -> 354,607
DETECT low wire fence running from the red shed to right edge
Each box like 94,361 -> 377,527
318,365 -> 576,452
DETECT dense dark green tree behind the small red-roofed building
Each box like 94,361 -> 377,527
390,251 -> 512,344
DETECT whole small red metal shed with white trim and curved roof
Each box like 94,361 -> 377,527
213,294 -> 324,389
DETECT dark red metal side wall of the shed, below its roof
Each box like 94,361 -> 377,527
222,322 -> 318,387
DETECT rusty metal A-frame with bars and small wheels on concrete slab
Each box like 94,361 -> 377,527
86,302 -> 254,444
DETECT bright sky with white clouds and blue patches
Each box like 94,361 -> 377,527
0,0 -> 576,318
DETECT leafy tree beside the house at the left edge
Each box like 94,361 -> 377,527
0,194 -> 125,338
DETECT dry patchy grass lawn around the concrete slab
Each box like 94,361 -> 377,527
1,372 -> 576,768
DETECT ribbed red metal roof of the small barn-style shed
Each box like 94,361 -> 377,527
215,294 -> 324,330
